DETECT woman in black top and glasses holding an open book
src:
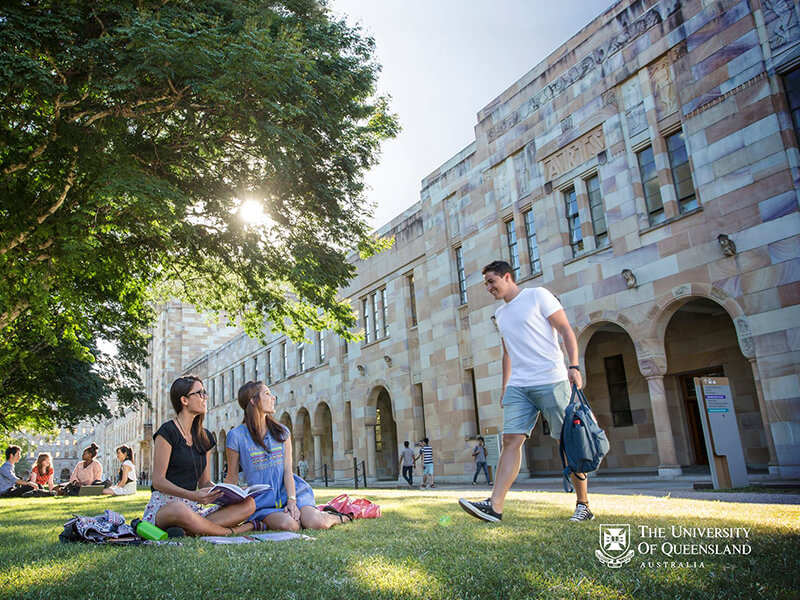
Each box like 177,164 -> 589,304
143,375 -> 255,535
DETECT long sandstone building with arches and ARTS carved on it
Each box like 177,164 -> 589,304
111,0 -> 800,481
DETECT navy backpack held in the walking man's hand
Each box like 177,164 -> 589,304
560,385 -> 609,492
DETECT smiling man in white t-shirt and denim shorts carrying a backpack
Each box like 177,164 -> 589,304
458,260 -> 594,523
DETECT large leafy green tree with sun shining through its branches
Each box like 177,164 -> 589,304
0,0 -> 397,427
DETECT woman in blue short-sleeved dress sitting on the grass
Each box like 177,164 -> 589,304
225,381 -> 351,531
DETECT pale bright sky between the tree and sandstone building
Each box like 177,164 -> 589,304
330,0 -> 614,229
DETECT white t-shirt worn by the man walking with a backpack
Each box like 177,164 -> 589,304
494,287 -> 567,387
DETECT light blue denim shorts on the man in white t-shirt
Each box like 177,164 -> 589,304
503,381 -> 569,440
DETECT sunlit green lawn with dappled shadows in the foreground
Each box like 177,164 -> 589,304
0,489 -> 800,600
